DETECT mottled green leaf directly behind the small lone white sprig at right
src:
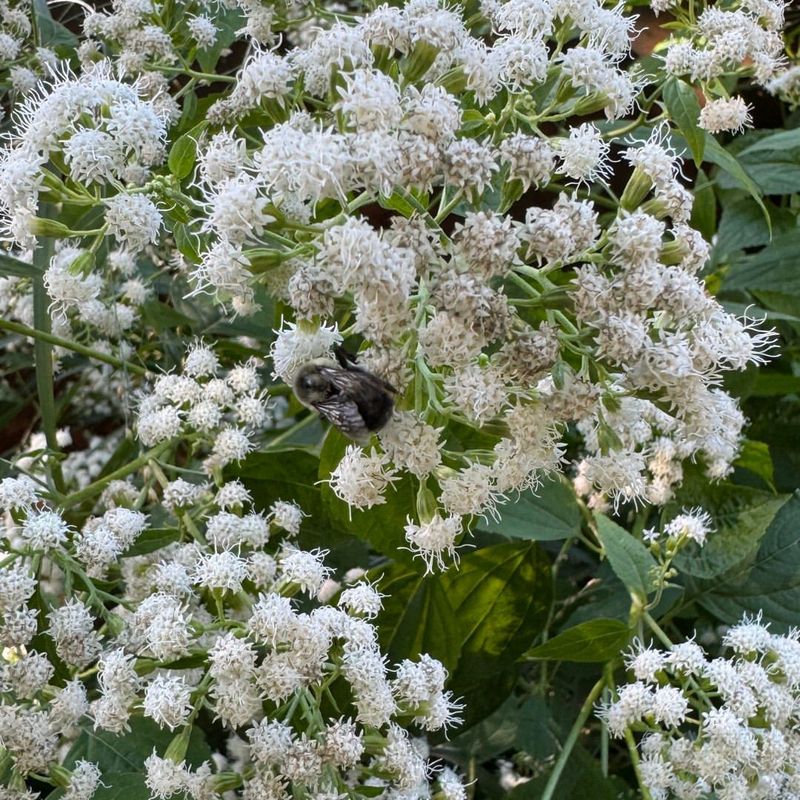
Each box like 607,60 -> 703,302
664,473 -> 786,578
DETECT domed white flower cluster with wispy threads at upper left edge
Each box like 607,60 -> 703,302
0,65 -> 166,248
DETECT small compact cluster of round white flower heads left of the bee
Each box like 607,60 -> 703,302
136,342 -> 270,473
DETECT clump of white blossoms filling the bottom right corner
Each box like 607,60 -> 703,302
598,616 -> 800,800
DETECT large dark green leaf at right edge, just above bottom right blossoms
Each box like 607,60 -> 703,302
690,491 -> 800,629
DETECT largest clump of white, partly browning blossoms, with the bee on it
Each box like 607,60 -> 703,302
142,0 -> 778,564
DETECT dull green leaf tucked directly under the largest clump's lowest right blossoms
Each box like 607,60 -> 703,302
480,479 -> 581,541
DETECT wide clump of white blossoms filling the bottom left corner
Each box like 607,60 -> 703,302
0,468 -> 463,800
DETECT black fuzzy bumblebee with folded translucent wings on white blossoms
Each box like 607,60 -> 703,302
294,349 -> 397,442
